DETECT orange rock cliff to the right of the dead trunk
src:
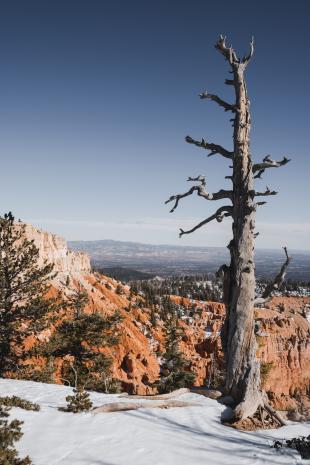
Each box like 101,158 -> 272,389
257,297 -> 310,410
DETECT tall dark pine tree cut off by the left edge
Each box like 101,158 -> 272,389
0,213 -> 56,377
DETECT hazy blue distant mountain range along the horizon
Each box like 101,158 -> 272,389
68,240 -> 310,281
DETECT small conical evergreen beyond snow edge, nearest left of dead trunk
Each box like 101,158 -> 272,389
155,316 -> 195,394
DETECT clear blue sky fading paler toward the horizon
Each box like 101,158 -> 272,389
0,0 -> 310,249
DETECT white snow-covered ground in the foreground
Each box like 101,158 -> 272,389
0,380 -> 310,465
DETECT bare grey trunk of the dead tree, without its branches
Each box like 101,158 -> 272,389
223,59 -> 262,419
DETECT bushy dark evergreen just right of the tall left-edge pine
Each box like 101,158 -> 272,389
46,291 -> 121,392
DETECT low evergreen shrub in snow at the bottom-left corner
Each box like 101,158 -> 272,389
0,405 -> 32,465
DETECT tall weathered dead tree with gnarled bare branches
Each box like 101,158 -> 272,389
166,36 -> 290,421
